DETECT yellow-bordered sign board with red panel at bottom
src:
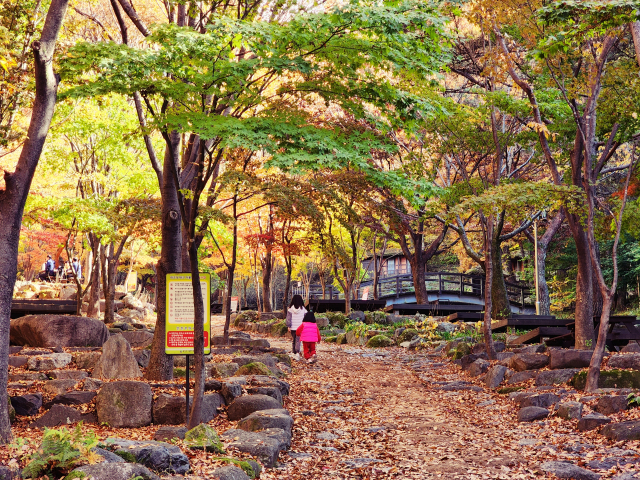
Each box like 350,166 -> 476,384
164,273 -> 211,355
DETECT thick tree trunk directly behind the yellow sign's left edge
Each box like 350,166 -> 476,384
146,132 -> 182,380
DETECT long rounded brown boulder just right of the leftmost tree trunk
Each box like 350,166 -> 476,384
10,315 -> 109,347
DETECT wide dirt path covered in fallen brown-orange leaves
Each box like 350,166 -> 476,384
215,316 -> 640,480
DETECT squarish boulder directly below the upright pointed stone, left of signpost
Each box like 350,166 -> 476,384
96,381 -> 153,428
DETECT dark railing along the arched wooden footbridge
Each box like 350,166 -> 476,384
293,272 -> 535,306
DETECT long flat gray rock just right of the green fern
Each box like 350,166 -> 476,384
104,438 -> 189,475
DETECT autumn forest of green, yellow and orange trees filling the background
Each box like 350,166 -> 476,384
0,0 -> 640,436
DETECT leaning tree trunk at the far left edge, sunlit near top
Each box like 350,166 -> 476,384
0,0 -> 69,444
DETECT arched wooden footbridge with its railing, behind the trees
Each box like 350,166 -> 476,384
293,272 -> 535,315
